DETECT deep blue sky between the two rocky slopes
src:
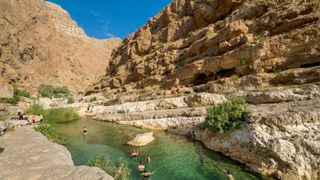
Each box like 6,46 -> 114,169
49,0 -> 172,39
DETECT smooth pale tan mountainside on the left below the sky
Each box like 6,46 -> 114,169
0,0 -> 121,91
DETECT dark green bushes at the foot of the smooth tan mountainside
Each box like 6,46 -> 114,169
38,84 -> 70,98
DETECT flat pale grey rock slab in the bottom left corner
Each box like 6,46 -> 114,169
0,127 -> 113,180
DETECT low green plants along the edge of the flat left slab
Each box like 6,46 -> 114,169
34,124 -> 67,144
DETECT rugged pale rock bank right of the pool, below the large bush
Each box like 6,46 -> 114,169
201,99 -> 320,180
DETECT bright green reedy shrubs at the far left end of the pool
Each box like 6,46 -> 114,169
26,104 -> 80,123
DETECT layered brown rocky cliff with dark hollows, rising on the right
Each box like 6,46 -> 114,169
95,0 -> 320,95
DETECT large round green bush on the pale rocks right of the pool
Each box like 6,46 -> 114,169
202,97 -> 249,134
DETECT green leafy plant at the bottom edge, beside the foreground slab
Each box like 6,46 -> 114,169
87,155 -> 130,180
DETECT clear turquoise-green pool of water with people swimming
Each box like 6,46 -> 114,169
60,119 -> 258,180
